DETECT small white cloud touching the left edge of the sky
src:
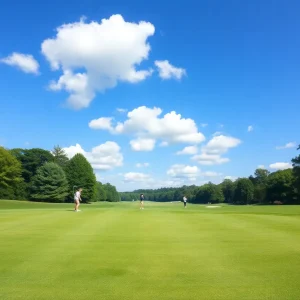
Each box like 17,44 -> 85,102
0,52 -> 40,74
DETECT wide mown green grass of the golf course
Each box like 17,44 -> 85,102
0,200 -> 300,300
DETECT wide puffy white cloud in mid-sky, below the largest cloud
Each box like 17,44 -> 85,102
89,106 -> 205,151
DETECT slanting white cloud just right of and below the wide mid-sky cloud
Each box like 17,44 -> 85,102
192,135 -> 241,165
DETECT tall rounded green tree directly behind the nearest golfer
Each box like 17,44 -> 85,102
65,153 -> 97,203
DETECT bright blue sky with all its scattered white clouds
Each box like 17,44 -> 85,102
0,0 -> 300,191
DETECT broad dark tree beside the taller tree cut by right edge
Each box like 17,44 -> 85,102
267,169 -> 296,203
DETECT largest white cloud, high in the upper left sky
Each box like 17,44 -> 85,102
41,15 -> 155,109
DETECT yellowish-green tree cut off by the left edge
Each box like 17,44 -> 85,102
0,147 -> 23,199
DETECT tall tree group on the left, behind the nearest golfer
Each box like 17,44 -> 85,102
0,146 -> 120,203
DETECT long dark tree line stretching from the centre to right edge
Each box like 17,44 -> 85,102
120,145 -> 300,204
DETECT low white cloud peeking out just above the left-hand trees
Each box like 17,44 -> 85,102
64,141 -> 123,170
